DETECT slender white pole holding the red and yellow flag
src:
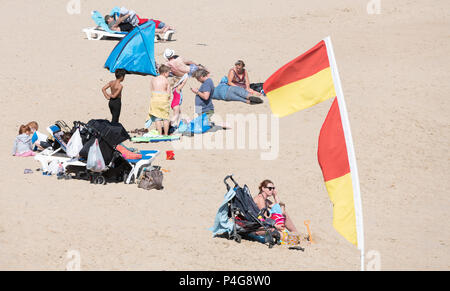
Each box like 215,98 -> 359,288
324,36 -> 364,271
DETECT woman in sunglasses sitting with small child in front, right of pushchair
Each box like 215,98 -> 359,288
253,180 -> 299,234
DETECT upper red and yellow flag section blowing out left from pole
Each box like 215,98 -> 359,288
264,41 -> 336,117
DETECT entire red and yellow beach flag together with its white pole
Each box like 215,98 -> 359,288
264,37 -> 364,270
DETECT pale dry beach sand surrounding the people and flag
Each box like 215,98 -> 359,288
0,0 -> 450,270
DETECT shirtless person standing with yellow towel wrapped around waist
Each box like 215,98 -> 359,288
149,65 -> 170,135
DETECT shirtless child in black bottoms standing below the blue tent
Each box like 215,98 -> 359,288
102,69 -> 126,123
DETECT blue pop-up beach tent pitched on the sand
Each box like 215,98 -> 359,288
105,21 -> 158,76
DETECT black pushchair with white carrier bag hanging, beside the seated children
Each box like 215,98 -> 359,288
66,119 -> 132,184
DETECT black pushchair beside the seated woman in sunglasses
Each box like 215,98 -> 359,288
223,175 -> 280,248
